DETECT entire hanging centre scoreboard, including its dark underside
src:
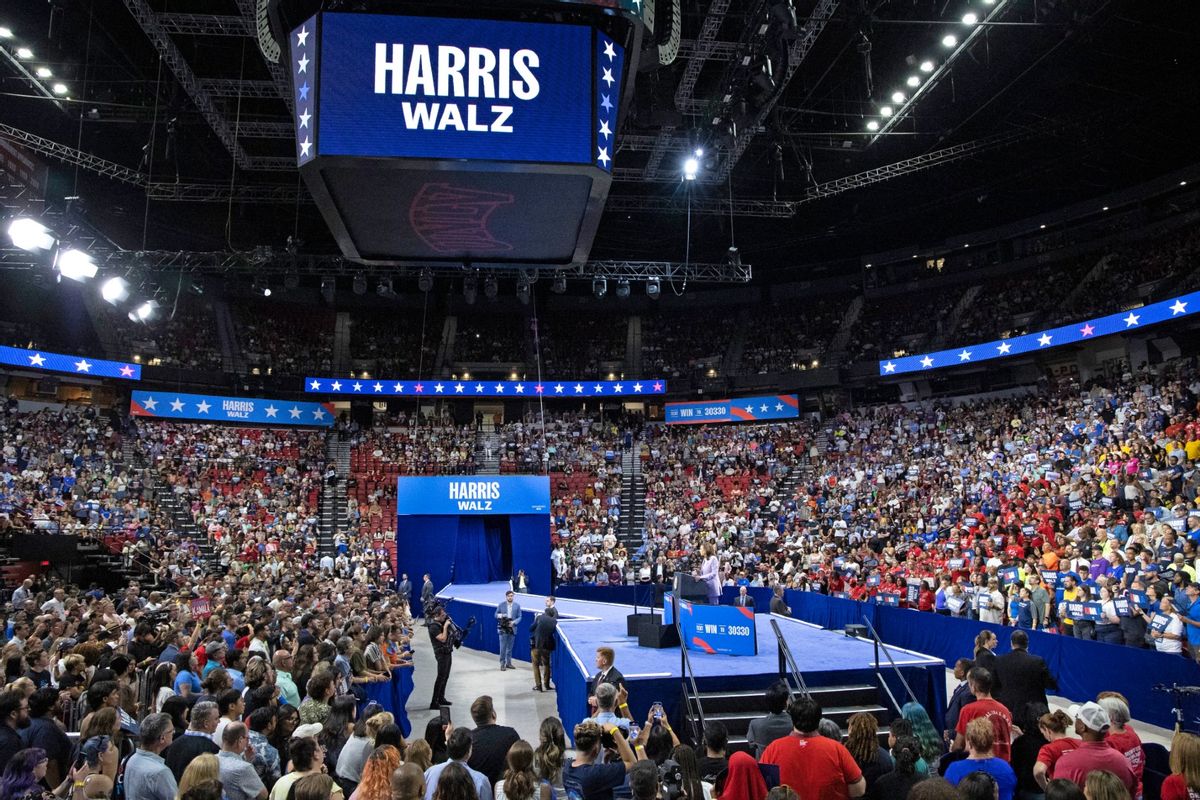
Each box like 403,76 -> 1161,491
289,12 -> 625,265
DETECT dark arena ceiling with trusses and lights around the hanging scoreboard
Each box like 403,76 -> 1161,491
0,0 -> 1200,279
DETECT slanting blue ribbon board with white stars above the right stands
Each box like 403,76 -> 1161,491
880,291 -> 1200,378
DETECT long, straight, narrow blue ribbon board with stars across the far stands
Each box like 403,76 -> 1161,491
304,377 -> 667,398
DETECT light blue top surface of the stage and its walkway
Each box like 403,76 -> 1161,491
438,583 -> 944,680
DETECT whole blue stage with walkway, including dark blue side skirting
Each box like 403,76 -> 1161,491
439,583 -> 946,730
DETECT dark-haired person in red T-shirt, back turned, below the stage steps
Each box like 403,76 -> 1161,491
758,697 -> 866,800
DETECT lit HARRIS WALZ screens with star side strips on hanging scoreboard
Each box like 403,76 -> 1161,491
307,12 -> 592,164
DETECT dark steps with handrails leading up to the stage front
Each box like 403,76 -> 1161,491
700,684 -> 892,752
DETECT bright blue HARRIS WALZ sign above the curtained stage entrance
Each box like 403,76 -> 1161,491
396,475 -> 550,517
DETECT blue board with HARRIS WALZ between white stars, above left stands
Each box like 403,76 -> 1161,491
130,391 -> 337,428
